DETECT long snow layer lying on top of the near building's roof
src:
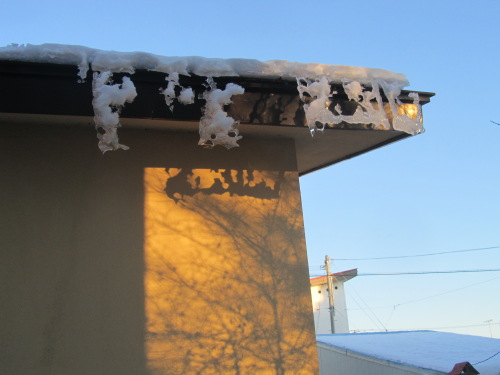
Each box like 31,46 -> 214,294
0,44 -> 409,87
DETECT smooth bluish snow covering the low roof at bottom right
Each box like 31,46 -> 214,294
316,331 -> 500,375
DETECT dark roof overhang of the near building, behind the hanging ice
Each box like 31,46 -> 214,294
0,61 -> 434,175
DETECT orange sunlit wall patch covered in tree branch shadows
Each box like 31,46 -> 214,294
145,168 -> 317,375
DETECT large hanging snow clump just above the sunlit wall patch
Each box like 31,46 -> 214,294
198,77 -> 245,148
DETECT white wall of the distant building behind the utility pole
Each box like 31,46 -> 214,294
311,281 -> 349,334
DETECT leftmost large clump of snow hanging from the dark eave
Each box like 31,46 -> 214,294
92,71 -> 137,153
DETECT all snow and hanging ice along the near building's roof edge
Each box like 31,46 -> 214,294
0,44 -> 423,151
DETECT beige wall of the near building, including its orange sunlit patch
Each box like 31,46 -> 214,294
0,124 -> 317,375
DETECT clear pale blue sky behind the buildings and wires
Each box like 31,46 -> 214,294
0,0 -> 500,338
